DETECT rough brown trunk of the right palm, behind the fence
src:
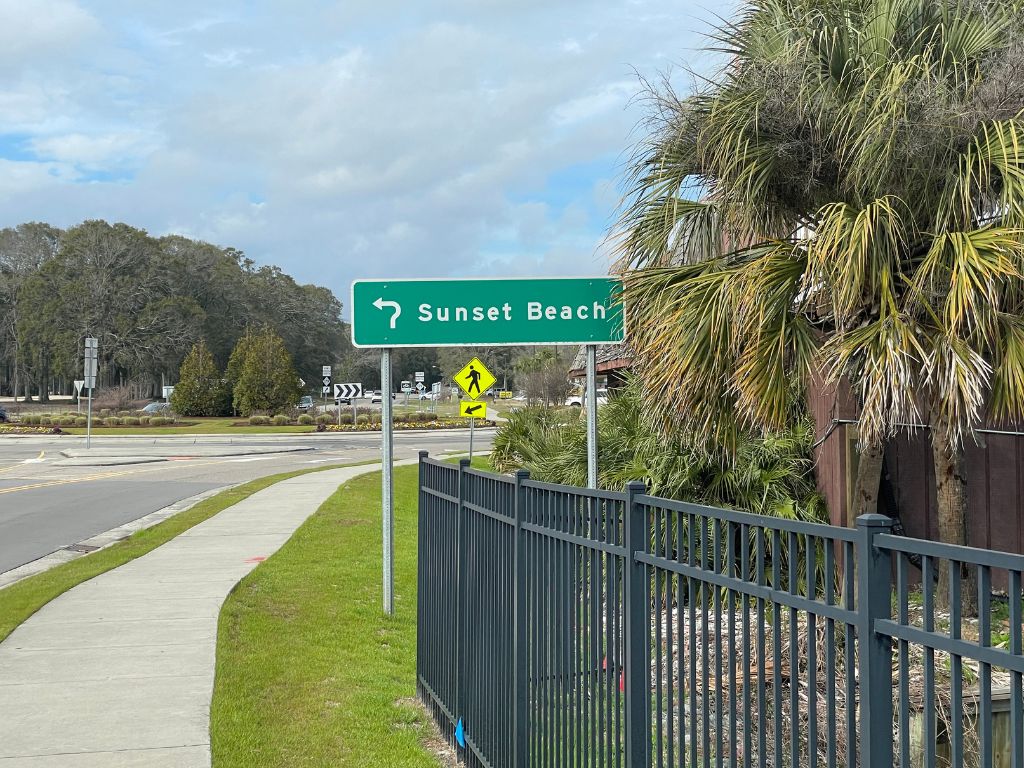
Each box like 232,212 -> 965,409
932,424 -> 978,616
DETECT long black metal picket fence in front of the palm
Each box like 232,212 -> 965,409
417,454 -> 1024,768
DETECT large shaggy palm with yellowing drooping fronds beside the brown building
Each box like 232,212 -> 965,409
618,0 -> 1024,608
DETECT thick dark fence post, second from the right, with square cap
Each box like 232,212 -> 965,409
623,480 -> 650,768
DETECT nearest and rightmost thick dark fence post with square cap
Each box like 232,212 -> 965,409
847,515 -> 894,768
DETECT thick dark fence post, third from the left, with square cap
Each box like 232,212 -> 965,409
512,469 -> 529,768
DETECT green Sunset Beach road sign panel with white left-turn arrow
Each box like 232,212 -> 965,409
349,276 -> 625,347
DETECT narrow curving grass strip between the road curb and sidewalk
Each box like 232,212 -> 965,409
0,465 -> 360,642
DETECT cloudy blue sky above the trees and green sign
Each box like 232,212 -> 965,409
0,0 -> 728,297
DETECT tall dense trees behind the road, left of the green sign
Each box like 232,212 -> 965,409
0,220 -> 348,401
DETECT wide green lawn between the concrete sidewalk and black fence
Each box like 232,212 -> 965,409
211,466 -> 438,768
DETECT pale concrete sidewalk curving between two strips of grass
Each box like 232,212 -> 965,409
0,462 -> 395,768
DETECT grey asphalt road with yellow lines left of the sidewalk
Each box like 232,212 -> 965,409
0,430 -> 492,573
